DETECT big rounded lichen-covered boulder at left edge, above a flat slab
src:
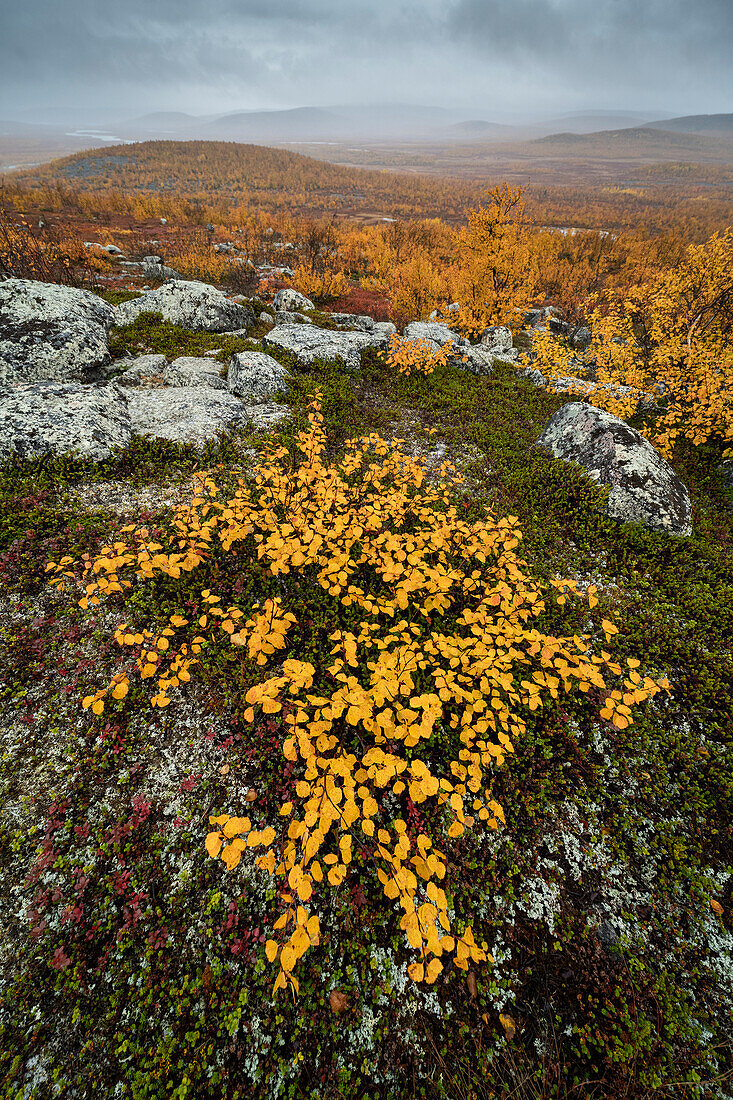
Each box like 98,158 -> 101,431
0,278 -> 114,385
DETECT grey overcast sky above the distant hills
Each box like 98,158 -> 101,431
0,0 -> 733,121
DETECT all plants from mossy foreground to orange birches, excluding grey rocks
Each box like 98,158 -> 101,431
0,159 -> 733,1100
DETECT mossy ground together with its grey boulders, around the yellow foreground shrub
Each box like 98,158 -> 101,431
0,270 -> 733,1100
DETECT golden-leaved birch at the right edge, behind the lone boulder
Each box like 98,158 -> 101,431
525,230 -> 733,457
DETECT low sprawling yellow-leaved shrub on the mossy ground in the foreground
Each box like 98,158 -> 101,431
48,395 -> 668,992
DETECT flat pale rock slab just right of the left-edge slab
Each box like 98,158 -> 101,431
128,386 -> 291,447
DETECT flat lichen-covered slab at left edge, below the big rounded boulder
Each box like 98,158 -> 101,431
0,382 -> 132,461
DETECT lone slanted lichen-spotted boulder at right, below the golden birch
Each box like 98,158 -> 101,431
538,402 -> 692,535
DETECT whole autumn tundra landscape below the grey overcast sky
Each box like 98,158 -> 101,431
0,0 -> 733,1100
